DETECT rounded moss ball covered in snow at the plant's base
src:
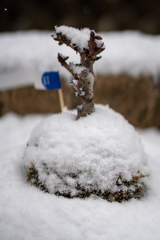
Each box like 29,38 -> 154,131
23,105 -> 148,202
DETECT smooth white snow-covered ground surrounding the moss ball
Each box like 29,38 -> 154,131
0,113 -> 160,240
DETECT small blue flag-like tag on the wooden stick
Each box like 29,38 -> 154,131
41,72 -> 61,90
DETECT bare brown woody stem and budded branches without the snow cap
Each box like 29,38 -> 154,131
52,27 -> 105,119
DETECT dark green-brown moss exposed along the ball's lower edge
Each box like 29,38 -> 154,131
27,165 -> 148,202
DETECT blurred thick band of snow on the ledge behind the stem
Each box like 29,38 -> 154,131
0,29 -> 160,89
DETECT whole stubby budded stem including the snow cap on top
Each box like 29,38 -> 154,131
52,26 -> 105,119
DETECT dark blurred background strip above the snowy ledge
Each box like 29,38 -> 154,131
0,0 -> 160,34
